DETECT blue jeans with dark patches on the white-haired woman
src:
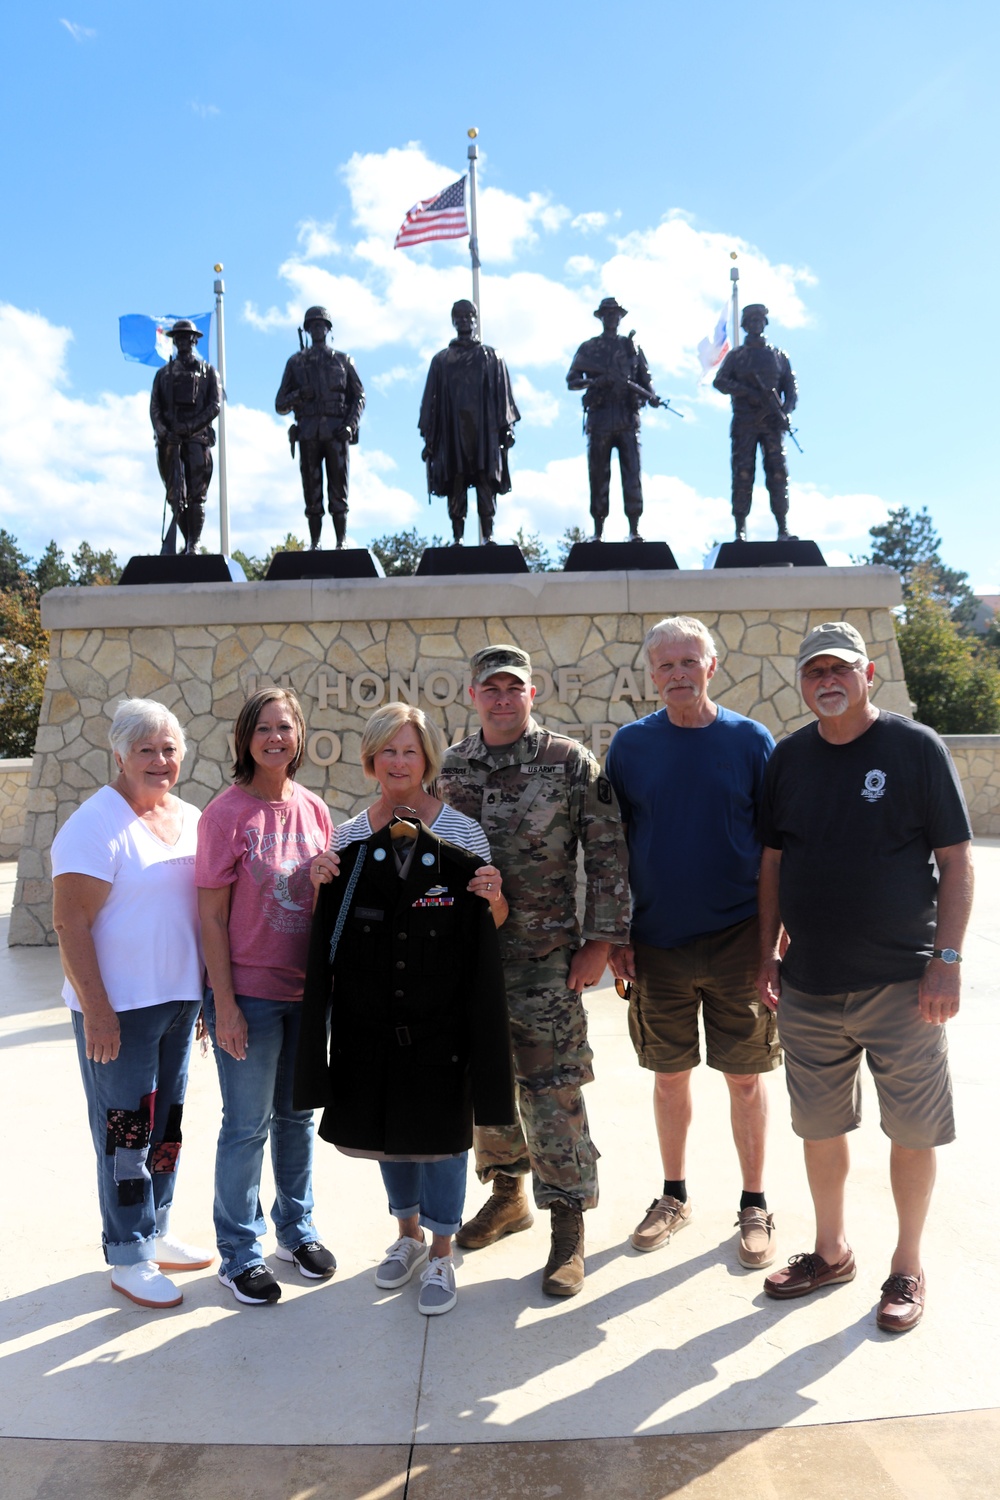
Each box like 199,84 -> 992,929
70,1001 -> 201,1266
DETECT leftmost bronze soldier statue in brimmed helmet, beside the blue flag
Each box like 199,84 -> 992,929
150,318 -> 220,555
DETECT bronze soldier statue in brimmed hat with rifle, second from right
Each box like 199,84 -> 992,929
567,297 -> 666,542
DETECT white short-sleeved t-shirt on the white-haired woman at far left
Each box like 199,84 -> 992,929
52,786 -> 204,1011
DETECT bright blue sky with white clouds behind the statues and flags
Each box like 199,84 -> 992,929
0,0 -> 1000,579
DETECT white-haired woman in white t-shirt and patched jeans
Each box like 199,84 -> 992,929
52,698 -> 213,1308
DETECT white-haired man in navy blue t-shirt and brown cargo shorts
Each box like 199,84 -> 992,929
607,615 -> 781,1271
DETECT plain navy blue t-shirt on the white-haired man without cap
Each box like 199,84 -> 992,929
606,708 -> 774,948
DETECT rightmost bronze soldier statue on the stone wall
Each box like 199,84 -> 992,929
712,302 -> 799,542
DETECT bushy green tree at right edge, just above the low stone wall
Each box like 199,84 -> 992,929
897,567 -> 1000,735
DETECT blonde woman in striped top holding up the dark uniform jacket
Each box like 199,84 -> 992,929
312,704 -> 507,1316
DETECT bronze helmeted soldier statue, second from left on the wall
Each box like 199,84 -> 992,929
274,308 -> 364,551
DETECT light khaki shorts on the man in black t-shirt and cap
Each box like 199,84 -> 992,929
778,980 -> 955,1151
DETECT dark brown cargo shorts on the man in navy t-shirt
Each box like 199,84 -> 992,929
628,917 -> 781,1073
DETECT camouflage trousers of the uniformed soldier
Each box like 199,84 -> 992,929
474,948 -> 600,1209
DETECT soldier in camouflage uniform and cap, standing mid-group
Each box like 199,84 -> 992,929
438,645 -> 630,1296
